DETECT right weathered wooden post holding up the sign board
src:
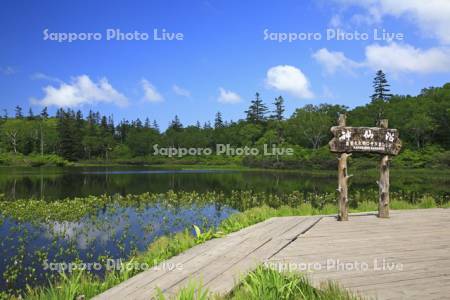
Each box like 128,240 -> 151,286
377,119 -> 389,218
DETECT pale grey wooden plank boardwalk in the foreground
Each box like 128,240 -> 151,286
95,209 -> 450,300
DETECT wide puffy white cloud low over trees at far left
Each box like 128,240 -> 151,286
31,75 -> 128,107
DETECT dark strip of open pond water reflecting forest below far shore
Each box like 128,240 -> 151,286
0,166 -> 450,201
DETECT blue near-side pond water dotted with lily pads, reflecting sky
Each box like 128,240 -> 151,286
0,203 -> 235,290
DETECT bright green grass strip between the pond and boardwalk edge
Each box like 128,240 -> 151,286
7,197 -> 449,299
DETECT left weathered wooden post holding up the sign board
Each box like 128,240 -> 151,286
338,114 -> 351,221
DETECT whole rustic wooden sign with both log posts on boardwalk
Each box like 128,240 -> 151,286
329,114 -> 402,221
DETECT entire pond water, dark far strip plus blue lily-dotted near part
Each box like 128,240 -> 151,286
0,167 -> 450,293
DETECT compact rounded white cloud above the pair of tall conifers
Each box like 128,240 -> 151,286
266,65 -> 314,98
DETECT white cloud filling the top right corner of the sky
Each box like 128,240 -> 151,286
335,0 -> 450,44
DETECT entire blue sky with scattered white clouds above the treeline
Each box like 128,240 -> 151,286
0,0 -> 450,128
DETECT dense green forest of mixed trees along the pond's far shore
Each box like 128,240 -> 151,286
0,71 -> 450,167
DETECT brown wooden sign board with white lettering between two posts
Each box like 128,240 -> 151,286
329,126 -> 402,155
